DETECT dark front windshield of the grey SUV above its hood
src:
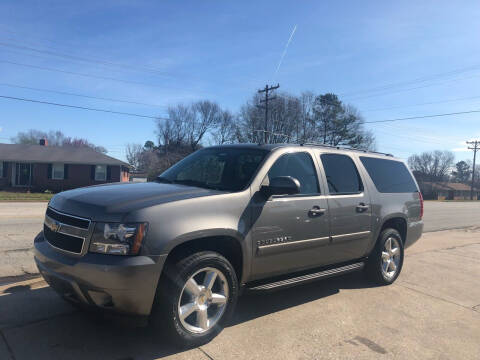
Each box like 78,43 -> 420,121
157,148 -> 268,191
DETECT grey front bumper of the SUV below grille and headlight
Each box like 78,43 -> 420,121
34,232 -> 166,316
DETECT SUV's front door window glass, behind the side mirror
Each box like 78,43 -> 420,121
267,152 -> 320,195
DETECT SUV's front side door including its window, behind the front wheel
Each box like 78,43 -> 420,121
252,152 -> 329,279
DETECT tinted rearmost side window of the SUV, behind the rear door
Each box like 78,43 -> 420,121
360,156 -> 417,193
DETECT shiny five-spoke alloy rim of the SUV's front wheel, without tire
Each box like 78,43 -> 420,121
178,267 -> 228,334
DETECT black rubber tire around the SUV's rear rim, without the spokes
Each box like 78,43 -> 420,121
366,229 -> 404,285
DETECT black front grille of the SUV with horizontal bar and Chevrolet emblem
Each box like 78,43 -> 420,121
43,208 -> 90,255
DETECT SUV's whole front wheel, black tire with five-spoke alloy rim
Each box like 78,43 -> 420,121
154,251 -> 238,346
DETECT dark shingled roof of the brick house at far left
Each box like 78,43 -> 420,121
0,144 -> 130,167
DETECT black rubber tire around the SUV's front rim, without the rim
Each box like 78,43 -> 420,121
151,251 -> 238,347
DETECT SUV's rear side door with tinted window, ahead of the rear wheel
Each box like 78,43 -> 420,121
320,152 -> 372,263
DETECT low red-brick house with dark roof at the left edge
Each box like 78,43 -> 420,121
0,140 -> 130,192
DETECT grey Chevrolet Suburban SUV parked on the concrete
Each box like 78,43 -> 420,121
35,144 -> 423,345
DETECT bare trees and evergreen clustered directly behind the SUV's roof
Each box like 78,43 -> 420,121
126,92 -> 375,179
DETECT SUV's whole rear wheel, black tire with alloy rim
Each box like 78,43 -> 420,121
367,229 -> 404,285
